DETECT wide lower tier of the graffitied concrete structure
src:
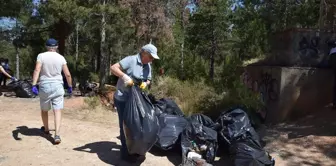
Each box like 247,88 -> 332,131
243,66 -> 333,123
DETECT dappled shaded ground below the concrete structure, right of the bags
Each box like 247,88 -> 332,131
264,108 -> 336,166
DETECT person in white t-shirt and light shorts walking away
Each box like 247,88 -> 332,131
32,39 -> 72,144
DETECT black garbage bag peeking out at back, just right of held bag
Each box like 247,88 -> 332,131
154,98 -> 184,116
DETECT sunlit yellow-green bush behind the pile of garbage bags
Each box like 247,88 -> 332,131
150,76 -> 262,123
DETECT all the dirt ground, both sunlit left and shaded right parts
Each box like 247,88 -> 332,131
0,97 -> 336,166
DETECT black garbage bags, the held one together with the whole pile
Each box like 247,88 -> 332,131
123,86 -> 275,166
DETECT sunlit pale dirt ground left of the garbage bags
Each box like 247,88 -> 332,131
0,97 -> 178,166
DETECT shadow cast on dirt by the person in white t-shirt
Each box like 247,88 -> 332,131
12,126 -> 54,144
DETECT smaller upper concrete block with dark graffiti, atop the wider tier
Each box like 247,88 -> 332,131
265,28 -> 335,67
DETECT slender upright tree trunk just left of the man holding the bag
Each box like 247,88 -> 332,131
99,0 -> 108,90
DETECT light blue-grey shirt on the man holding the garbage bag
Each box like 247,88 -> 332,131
114,54 -> 152,101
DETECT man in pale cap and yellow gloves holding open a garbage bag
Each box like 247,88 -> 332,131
111,44 -> 159,162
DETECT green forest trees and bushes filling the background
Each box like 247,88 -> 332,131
0,0 -> 319,118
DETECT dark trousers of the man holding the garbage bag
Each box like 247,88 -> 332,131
114,98 -> 129,157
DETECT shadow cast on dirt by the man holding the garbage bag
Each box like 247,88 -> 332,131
73,141 -> 143,166
